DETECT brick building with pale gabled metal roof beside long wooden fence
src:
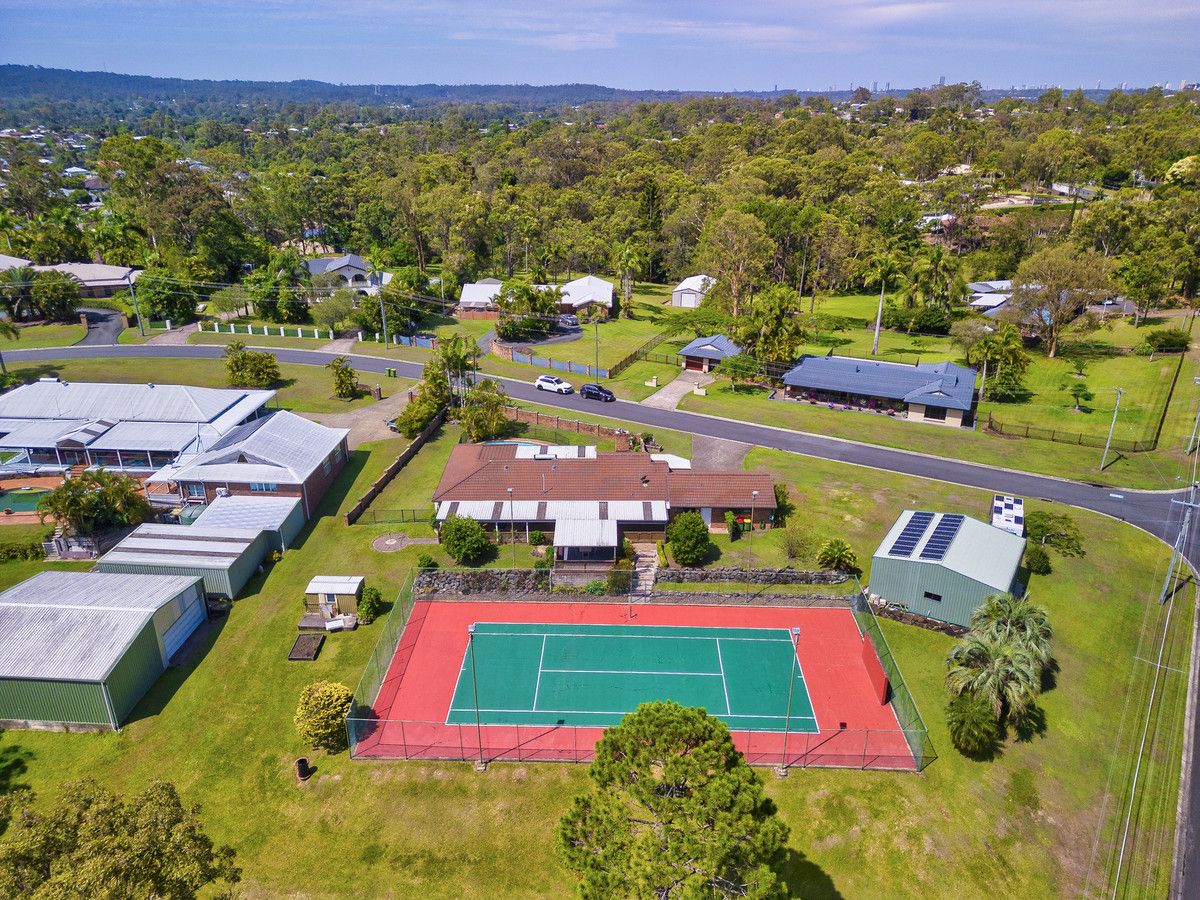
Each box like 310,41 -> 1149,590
146,410 -> 350,518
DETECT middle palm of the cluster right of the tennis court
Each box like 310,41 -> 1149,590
946,631 -> 1042,721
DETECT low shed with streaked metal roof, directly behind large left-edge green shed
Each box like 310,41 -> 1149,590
96,524 -> 268,599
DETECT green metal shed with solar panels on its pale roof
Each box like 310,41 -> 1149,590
870,510 -> 1025,626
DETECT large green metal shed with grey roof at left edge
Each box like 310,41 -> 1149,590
0,571 -> 206,728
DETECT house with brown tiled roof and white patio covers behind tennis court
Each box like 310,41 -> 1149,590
433,444 -> 775,562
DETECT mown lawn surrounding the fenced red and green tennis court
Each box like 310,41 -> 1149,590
0,440 -> 1192,898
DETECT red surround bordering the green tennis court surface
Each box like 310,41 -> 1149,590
352,601 -> 916,770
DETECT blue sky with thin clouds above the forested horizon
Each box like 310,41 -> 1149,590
0,0 -> 1200,90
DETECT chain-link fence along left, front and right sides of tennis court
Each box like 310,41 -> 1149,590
346,572 -> 937,772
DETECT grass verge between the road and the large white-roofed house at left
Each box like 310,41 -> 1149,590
8,358 -> 379,413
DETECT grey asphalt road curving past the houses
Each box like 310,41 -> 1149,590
6,340 -> 1200,896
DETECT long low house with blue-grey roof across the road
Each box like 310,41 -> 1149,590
784,355 -> 977,427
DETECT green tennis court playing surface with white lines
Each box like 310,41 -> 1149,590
446,623 -> 818,733
